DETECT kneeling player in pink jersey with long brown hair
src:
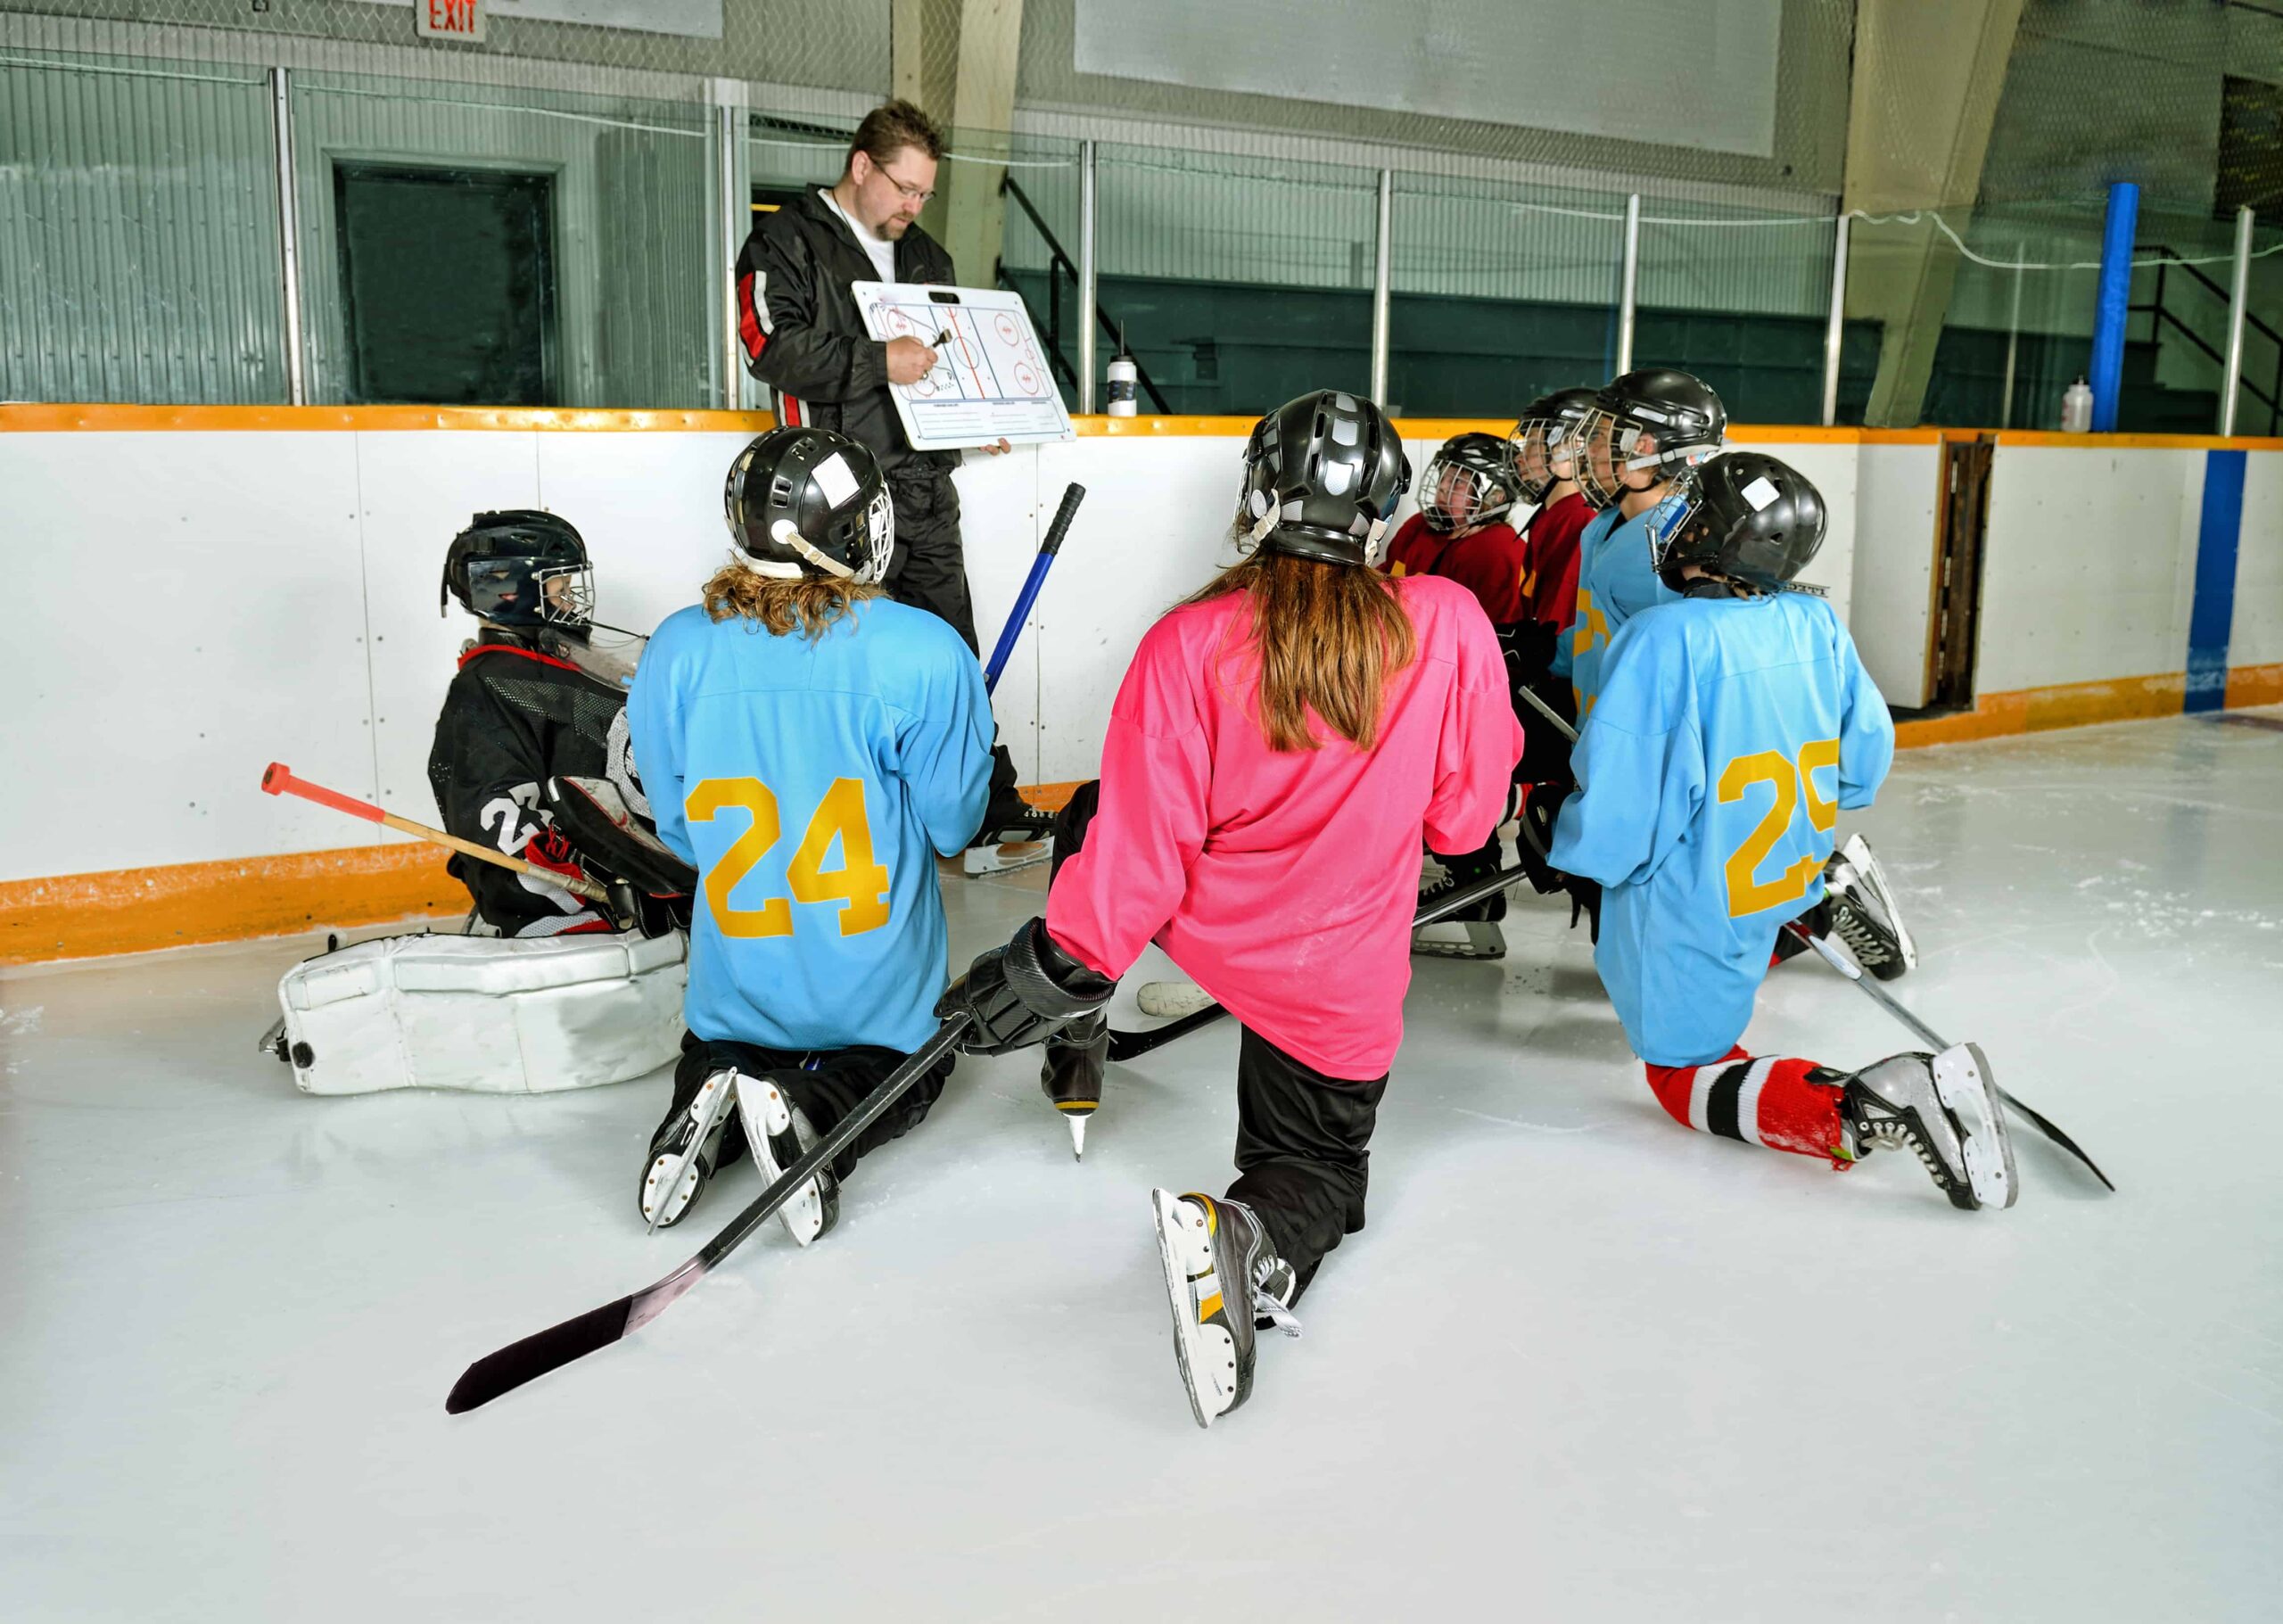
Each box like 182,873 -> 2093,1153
943,391 -> 1523,1425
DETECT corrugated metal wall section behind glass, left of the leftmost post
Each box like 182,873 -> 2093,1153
0,60 -> 285,402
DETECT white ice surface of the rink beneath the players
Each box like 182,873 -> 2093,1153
0,720 -> 2283,1624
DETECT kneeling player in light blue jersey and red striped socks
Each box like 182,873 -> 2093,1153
1553,452 -> 2015,1208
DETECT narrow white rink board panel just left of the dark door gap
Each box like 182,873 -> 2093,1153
1847,445 -> 1943,711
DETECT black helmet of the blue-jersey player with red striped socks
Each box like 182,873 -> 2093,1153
1648,452 -> 1824,591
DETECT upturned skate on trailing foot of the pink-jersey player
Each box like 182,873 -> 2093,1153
1149,1190 -> 1299,1428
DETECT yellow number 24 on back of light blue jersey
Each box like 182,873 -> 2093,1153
682,779 -> 888,936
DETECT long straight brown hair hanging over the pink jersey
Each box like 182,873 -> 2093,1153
1190,550 -> 1418,749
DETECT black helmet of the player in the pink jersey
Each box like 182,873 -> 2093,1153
1238,388 -> 1411,565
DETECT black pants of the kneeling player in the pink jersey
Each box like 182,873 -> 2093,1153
1048,783 -> 1388,1298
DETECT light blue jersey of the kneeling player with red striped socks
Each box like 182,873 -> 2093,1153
1553,591 -> 1895,1067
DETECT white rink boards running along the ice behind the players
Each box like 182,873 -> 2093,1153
0,430 -> 2283,879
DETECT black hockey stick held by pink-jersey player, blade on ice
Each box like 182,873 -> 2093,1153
443,1014 -> 968,1416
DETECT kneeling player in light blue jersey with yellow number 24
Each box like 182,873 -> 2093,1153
631,427 -> 991,1245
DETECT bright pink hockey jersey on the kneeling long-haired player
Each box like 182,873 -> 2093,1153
1045,575 -> 1523,1078
